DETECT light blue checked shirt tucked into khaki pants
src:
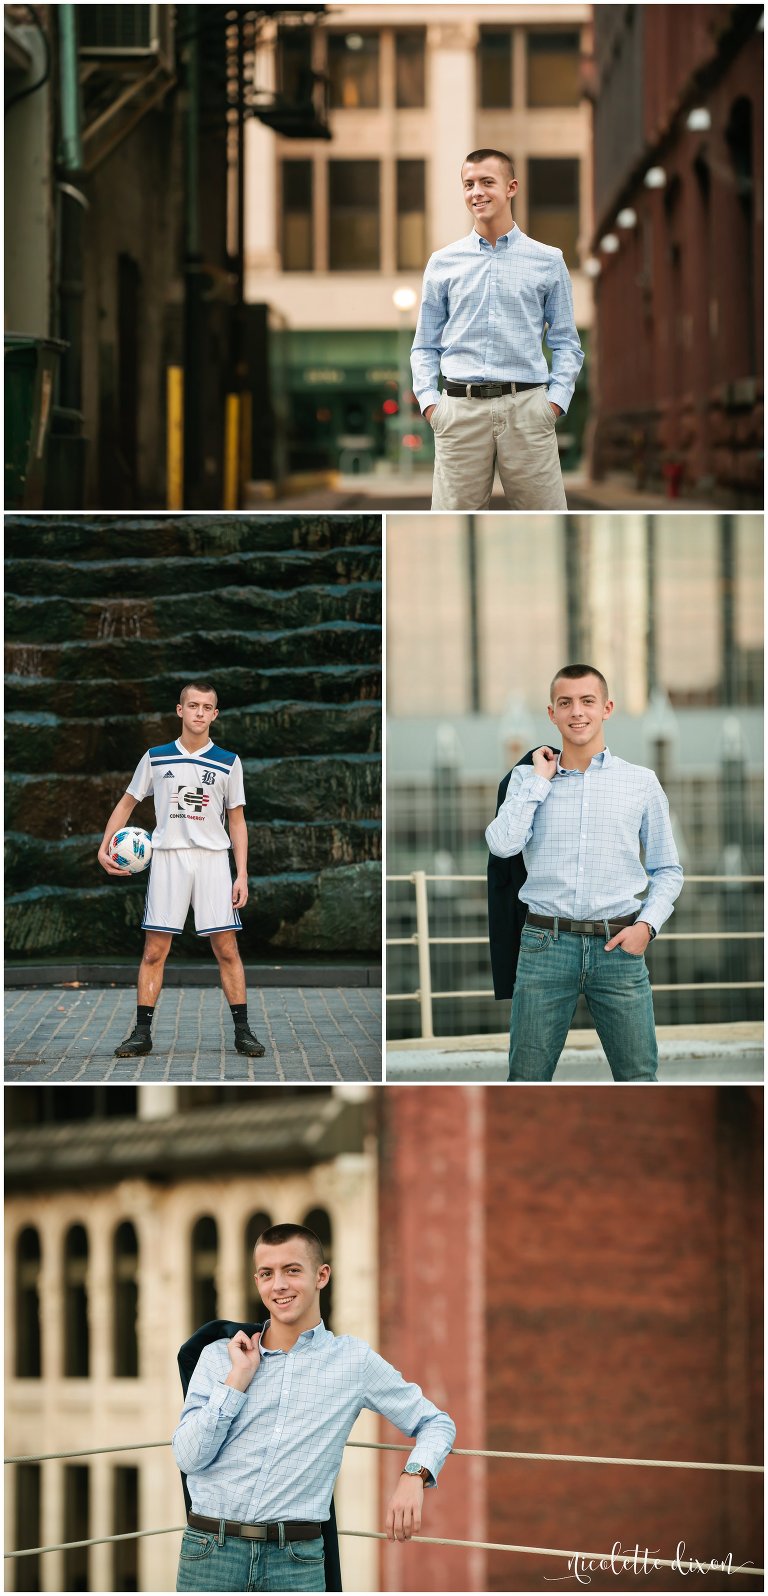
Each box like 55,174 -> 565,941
410,227 -> 584,410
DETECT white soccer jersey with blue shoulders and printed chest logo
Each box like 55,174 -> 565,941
128,741 -> 246,849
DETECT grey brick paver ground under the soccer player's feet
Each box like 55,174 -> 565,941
5,986 -> 382,1084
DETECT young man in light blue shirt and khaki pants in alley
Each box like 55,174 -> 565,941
410,150 -> 584,509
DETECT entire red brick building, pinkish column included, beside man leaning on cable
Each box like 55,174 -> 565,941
377,1087 -> 762,1591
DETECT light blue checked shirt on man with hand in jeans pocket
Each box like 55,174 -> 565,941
485,749 -> 683,930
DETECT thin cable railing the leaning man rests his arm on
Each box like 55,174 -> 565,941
3,1441 -> 765,1578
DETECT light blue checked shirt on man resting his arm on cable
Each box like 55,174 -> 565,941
172,1321 -> 457,1524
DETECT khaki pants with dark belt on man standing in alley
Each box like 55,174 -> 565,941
430,385 -> 568,509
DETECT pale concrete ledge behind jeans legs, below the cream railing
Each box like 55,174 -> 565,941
386,1021 -> 763,1085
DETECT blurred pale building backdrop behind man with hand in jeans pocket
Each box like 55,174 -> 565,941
386,514 -> 763,1039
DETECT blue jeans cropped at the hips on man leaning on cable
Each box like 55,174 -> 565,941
176,1529 -> 326,1591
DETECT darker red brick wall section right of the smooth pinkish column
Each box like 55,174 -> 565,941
485,1087 -> 762,1590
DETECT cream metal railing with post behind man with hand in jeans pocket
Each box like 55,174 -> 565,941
386,870 -> 765,1041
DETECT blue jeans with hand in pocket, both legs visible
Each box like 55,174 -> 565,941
509,926 -> 658,1080
